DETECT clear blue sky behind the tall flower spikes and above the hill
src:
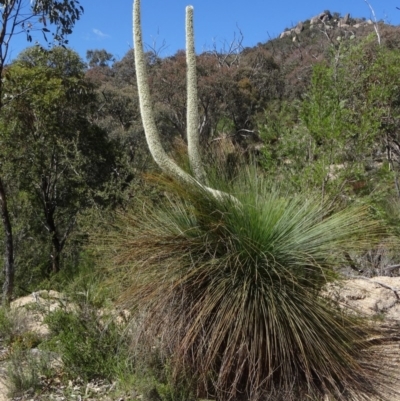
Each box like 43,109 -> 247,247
5,0 -> 400,60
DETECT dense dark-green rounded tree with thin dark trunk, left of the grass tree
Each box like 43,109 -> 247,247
0,46 -> 114,272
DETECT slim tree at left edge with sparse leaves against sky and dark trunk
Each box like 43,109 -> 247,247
0,0 -> 83,303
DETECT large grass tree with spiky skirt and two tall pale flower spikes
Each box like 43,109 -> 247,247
123,0 -> 398,401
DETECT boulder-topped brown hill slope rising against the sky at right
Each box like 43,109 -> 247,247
255,11 -> 400,99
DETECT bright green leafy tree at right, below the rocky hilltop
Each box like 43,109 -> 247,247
301,39 -> 400,162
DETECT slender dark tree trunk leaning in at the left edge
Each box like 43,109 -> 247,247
0,178 -> 14,305
